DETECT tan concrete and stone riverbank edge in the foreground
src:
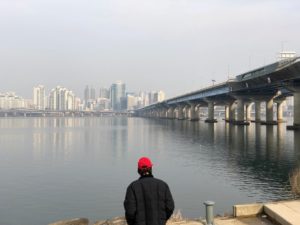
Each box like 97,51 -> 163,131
49,200 -> 300,225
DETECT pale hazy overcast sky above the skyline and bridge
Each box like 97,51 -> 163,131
0,0 -> 300,97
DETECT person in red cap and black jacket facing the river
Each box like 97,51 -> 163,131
124,157 -> 174,225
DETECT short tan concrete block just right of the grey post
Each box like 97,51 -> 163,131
233,203 -> 264,217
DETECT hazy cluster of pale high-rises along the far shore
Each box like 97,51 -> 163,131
0,81 -> 165,111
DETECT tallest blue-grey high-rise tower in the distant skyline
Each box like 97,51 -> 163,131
110,81 -> 126,111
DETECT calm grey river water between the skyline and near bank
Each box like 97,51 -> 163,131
0,117 -> 300,225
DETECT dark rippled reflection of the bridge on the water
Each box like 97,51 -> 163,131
142,119 -> 300,201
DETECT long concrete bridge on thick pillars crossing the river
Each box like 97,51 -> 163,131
136,57 -> 300,129
